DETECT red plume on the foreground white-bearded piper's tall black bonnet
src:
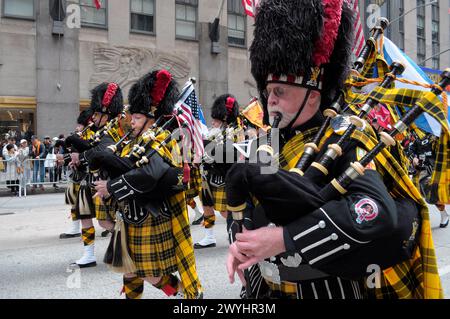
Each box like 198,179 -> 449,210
313,0 -> 344,66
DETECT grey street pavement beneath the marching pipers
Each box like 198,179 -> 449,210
0,193 -> 450,299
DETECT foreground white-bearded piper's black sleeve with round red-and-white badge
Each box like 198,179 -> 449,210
284,170 -> 397,267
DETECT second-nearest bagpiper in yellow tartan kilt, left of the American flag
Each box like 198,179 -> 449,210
92,70 -> 203,299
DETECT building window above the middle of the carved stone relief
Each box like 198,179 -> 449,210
130,0 -> 155,33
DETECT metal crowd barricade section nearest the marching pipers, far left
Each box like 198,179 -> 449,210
22,159 -> 68,196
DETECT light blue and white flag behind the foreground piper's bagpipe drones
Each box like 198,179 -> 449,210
383,37 -> 450,136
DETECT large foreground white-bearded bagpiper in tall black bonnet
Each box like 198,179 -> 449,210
225,0 -> 442,299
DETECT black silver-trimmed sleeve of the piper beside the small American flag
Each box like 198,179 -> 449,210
107,154 -> 170,201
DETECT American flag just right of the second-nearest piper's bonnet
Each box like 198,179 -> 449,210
175,81 -> 206,161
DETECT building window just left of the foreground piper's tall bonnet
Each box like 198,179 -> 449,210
228,0 -> 246,46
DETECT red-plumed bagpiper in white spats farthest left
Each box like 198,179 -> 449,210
66,82 -> 124,268
